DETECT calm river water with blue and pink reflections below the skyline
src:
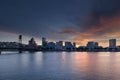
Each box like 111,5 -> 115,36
0,52 -> 120,80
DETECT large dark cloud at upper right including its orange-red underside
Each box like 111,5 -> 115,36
61,0 -> 120,36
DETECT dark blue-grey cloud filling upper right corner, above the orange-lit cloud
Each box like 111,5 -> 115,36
80,0 -> 120,28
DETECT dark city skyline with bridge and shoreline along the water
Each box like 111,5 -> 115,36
0,35 -> 120,53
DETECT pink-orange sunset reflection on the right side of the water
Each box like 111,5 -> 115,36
69,53 -> 120,80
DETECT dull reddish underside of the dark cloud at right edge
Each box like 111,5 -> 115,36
88,15 -> 120,33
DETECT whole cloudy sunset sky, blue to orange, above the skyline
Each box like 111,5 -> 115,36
0,0 -> 120,47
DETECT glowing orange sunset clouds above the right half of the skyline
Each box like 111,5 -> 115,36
58,14 -> 120,46
